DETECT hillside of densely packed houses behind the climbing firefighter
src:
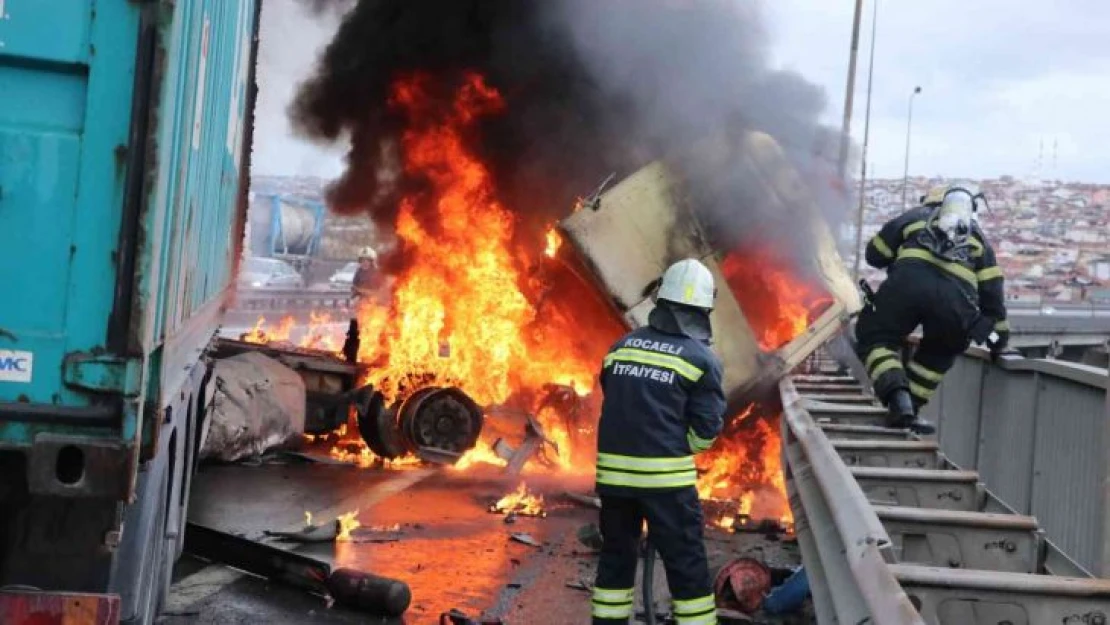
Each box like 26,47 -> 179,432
840,175 -> 1110,303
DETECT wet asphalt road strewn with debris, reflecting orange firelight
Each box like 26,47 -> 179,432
159,452 -> 810,625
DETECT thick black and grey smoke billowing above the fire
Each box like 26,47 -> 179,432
291,0 -> 847,274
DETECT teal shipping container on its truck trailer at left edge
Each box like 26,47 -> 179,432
0,0 -> 260,623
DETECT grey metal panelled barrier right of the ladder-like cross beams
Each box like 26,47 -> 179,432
925,347 -> 1110,577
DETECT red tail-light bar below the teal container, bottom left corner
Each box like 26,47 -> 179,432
0,591 -> 120,625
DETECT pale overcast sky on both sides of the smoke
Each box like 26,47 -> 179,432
254,0 -> 1110,182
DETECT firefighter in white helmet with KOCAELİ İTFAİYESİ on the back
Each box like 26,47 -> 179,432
592,259 -> 725,625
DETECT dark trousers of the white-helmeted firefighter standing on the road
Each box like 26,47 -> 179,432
591,486 -> 717,625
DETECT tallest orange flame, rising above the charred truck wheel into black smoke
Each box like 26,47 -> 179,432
359,74 -> 599,405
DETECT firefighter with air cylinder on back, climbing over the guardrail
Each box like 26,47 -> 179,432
856,184 -> 1010,434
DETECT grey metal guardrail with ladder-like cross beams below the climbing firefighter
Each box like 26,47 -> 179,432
779,359 -> 1110,625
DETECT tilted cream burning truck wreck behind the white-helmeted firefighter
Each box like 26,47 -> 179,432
558,127 -> 861,414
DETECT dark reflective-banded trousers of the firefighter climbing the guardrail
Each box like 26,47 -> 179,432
856,263 -> 979,409
